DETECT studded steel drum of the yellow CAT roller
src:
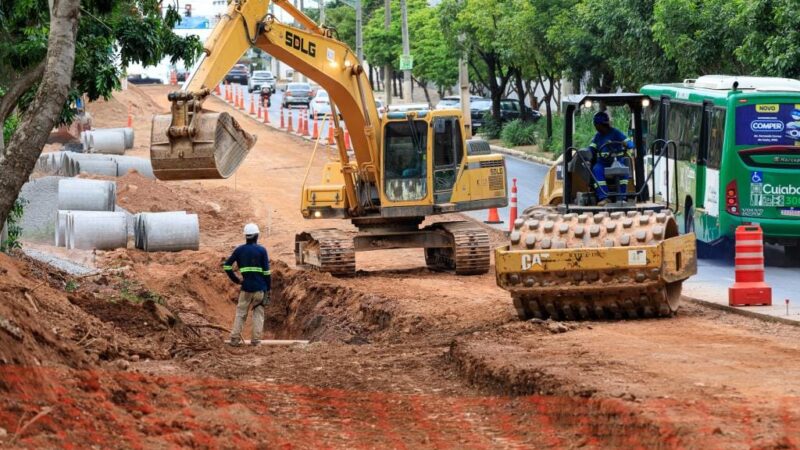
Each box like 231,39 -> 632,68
498,208 -> 682,320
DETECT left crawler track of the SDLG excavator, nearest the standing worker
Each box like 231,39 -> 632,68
294,228 -> 356,277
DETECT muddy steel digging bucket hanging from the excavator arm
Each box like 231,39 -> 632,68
150,106 -> 256,180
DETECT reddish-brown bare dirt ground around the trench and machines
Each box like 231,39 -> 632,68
0,83 -> 800,448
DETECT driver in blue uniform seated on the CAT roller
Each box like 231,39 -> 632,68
589,111 -> 634,206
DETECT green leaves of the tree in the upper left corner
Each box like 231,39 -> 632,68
0,0 -> 202,123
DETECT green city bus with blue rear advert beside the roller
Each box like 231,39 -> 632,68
641,75 -> 800,256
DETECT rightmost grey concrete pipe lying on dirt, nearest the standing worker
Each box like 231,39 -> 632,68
133,211 -> 200,252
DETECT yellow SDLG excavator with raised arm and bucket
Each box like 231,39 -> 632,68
150,0 -> 508,276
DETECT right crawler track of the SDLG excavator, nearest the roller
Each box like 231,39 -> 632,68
425,222 -> 491,275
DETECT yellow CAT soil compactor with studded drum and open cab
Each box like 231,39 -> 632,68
495,93 -> 697,320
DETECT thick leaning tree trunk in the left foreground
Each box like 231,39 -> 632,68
0,0 -> 80,227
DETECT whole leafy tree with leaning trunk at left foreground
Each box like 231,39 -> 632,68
0,0 -> 202,230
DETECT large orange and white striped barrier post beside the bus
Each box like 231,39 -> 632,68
728,224 -> 772,306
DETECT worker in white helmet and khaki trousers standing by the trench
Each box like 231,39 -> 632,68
222,223 -> 271,347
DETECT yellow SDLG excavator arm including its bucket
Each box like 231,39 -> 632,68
151,0 -> 380,215
